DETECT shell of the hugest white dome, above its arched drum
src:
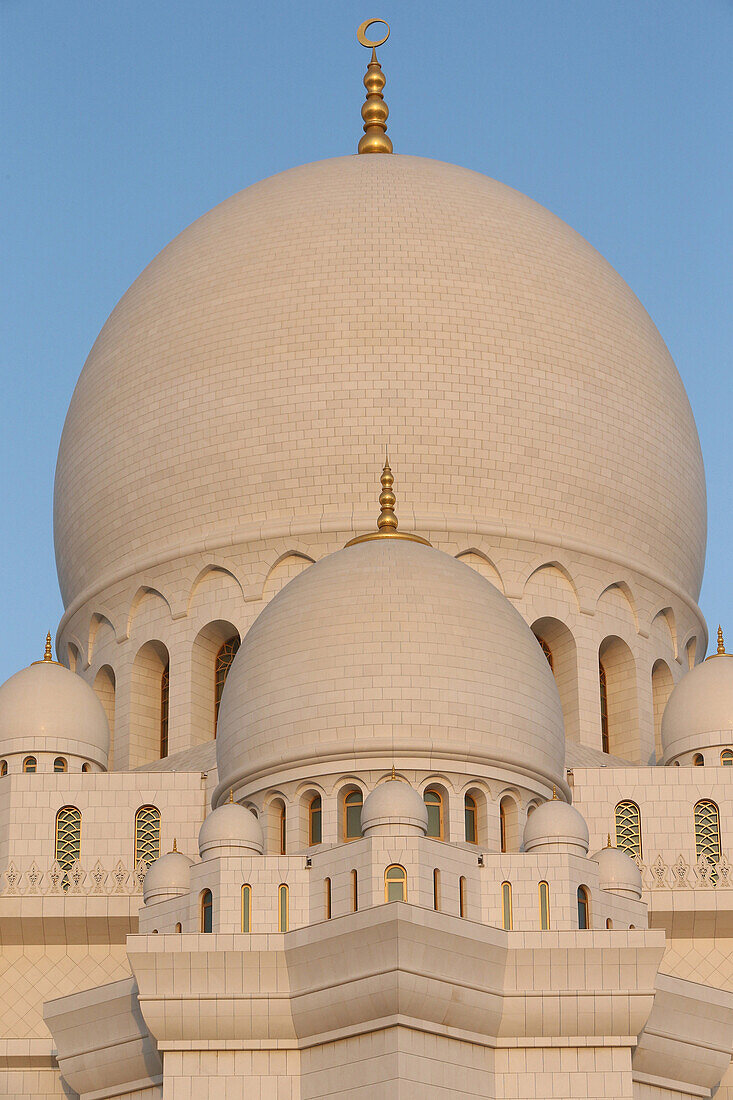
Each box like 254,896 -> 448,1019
55,156 -> 705,607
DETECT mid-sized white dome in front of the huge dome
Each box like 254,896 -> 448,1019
214,538 -> 566,803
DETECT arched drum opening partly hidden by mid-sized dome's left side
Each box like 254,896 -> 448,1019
190,619 -> 241,745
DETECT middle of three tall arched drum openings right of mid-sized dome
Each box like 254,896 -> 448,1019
599,636 -> 639,763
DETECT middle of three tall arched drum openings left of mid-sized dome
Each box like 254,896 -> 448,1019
129,641 -> 171,768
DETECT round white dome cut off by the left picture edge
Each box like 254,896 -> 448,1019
0,646 -> 109,770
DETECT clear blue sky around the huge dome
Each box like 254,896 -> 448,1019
0,0 -> 733,680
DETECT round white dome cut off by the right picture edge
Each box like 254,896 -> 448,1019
661,653 -> 733,763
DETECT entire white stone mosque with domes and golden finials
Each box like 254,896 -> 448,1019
0,21 -> 733,1100
